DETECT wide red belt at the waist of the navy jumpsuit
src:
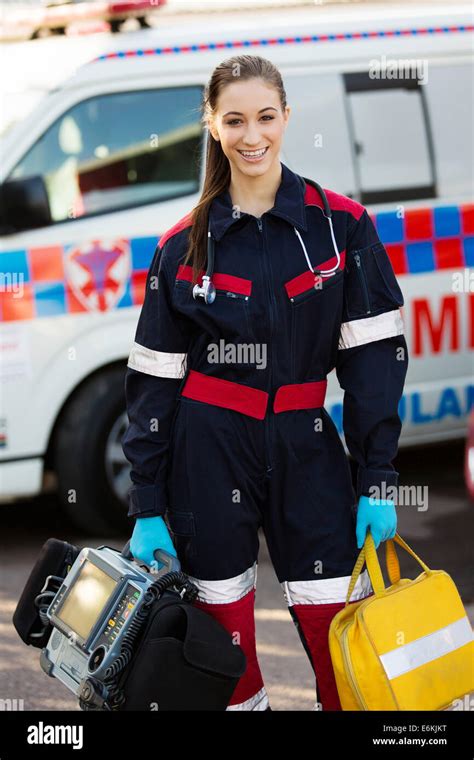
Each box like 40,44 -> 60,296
181,369 -> 327,420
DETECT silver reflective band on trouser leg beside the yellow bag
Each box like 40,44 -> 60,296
280,569 -> 373,607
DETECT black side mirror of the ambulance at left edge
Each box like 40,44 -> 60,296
0,175 -> 52,235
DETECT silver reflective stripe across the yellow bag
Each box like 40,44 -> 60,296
380,616 -> 473,680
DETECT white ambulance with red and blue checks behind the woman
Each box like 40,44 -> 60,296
0,4 -> 474,535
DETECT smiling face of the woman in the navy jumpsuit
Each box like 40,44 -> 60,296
209,78 -> 290,177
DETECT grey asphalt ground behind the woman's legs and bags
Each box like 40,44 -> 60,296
0,442 -> 474,711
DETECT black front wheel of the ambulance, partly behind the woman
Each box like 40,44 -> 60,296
53,367 -> 133,536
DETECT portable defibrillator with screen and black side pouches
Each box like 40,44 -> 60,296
13,539 -> 246,710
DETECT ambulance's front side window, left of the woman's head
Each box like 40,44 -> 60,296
8,86 -> 203,222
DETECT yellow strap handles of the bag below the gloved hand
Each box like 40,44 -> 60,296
346,531 -> 431,606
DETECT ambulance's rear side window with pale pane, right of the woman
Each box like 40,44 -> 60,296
343,72 -> 437,205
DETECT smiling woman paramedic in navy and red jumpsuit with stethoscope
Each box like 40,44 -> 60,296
122,55 -> 408,710
